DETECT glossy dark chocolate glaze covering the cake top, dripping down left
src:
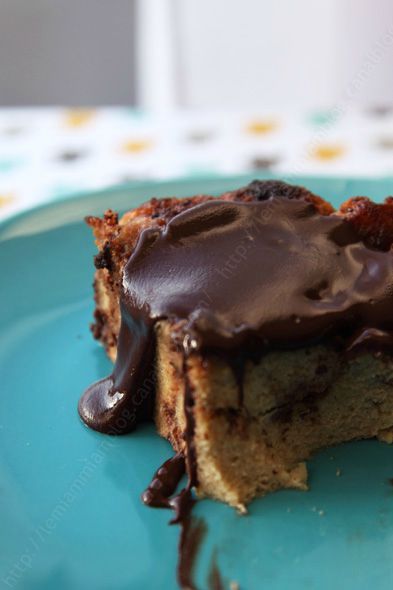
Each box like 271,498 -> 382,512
79,189 -> 393,440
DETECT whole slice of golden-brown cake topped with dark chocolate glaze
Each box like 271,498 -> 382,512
79,181 -> 393,506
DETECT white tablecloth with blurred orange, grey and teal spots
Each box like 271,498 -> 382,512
0,105 -> 393,219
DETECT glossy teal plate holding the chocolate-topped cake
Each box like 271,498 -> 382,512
0,177 -> 393,590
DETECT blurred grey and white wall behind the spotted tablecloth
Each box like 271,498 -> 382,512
0,0 -> 393,108
